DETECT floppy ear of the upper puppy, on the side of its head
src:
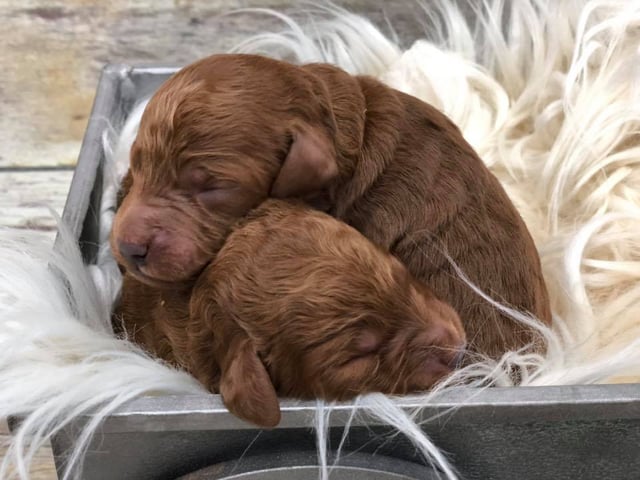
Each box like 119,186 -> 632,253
271,124 -> 338,198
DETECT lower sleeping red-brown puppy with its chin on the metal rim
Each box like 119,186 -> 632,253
116,200 -> 465,426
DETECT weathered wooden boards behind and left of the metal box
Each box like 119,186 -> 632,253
0,0 -> 436,480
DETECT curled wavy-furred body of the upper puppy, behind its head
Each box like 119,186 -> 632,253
331,78 -> 551,357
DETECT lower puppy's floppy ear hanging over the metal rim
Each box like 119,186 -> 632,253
220,339 -> 280,427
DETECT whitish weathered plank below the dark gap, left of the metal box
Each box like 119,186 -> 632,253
0,170 -> 73,233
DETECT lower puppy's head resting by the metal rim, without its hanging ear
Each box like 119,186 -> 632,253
208,201 -> 466,404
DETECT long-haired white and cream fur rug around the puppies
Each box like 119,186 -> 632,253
0,0 -> 640,479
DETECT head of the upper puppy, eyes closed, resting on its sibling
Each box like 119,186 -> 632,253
111,55 -> 360,286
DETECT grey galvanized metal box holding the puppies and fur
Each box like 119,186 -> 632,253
53,65 -> 640,480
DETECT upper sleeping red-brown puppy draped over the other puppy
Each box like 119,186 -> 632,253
112,55 -> 551,357
